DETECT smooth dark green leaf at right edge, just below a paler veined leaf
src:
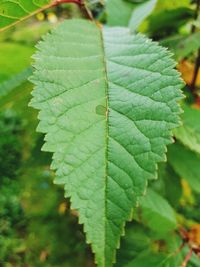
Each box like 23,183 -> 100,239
168,142 -> 200,193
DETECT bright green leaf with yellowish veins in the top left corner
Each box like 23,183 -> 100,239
0,0 -> 52,31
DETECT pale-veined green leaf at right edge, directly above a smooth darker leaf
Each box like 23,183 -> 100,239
174,105 -> 200,153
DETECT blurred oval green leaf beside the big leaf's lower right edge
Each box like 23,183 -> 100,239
138,189 -> 177,234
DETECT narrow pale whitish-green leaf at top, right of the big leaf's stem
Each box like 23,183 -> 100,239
129,0 -> 157,32
